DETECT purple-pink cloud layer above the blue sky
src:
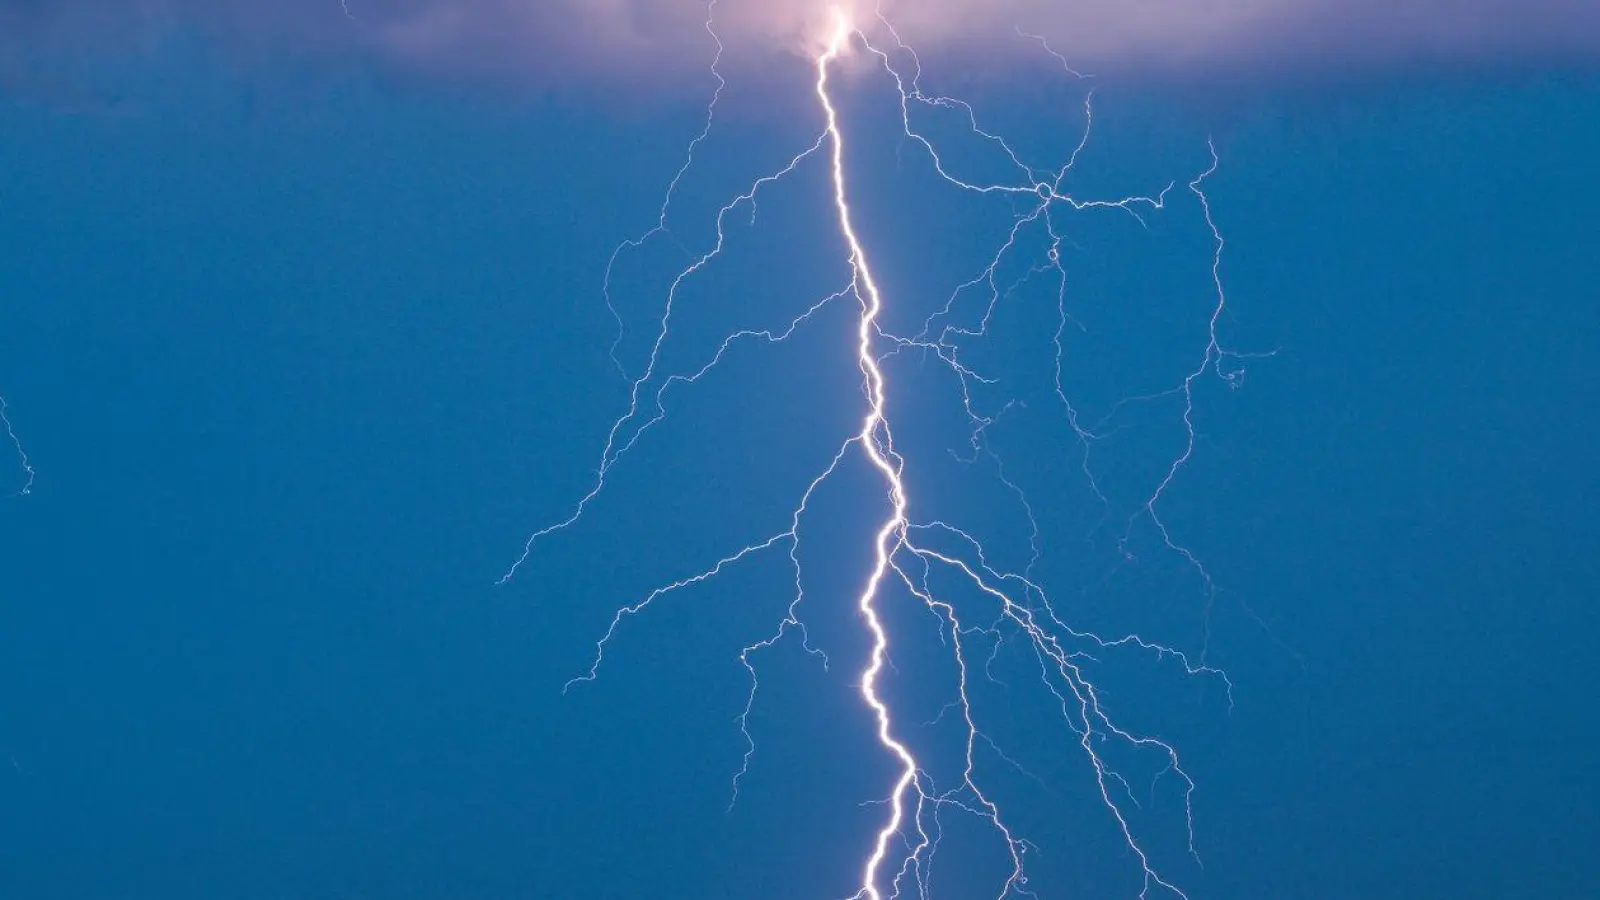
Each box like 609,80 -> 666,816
0,0 -> 1600,94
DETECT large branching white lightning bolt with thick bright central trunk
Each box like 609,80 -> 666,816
501,0 -> 1269,900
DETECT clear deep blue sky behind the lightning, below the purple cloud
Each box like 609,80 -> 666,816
0,19 -> 1600,900
